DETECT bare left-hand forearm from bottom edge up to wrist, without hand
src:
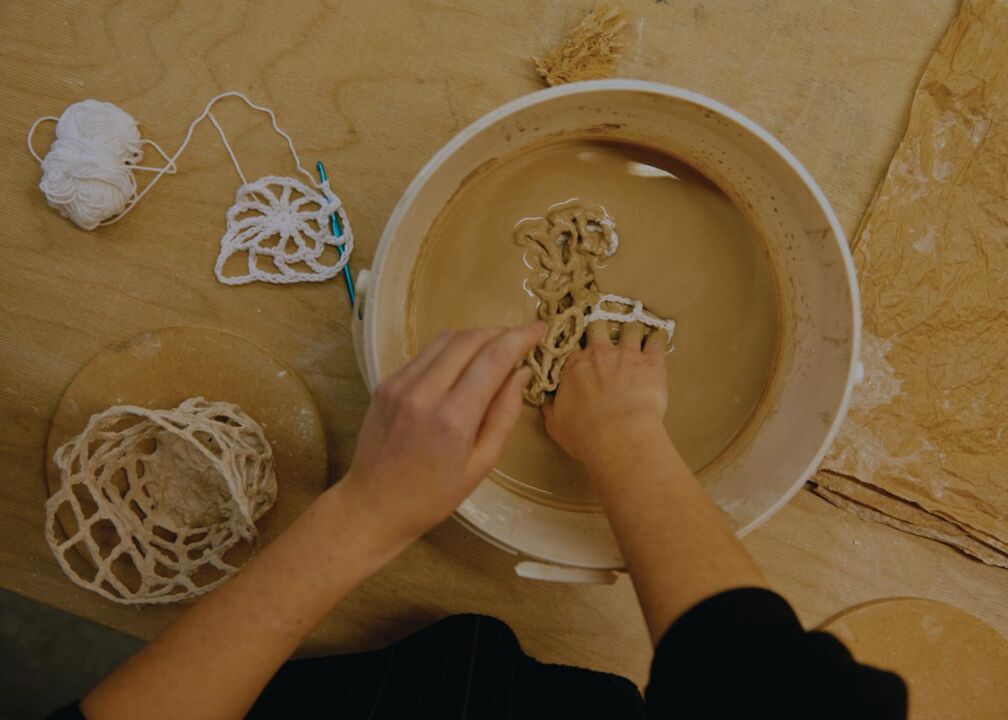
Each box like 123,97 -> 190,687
82,475 -> 407,718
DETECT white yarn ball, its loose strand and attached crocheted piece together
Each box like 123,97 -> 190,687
28,91 -> 354,285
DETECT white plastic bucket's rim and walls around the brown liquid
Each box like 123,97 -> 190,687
354,80 -> 861,582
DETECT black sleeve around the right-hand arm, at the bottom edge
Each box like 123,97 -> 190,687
645,589 -> 906,720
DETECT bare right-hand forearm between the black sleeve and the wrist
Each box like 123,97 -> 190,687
590,426 -> 765,642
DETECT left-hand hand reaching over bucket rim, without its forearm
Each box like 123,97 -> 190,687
339,323 -> 544,542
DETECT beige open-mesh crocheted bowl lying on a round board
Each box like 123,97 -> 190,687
45,397 -> 276,604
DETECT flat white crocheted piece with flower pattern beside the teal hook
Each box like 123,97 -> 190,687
214,175 -> 354,285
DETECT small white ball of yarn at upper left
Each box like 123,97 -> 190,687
38,100 -> 142,230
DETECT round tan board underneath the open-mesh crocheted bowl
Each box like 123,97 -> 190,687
45,328 -> 328,545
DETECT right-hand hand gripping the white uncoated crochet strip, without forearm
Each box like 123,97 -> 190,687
542,321 -> 668,465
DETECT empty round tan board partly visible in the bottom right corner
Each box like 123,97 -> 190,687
823,598 -> 1008,720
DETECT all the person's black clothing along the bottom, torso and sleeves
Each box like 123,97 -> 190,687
56,589 -> 906,720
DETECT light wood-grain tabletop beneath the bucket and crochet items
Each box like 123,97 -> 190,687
0,0 -> 1008,682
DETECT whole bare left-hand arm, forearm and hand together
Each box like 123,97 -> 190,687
82,323 -> 544,718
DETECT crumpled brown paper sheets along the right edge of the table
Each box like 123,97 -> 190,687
813,0 -> 1008,568
